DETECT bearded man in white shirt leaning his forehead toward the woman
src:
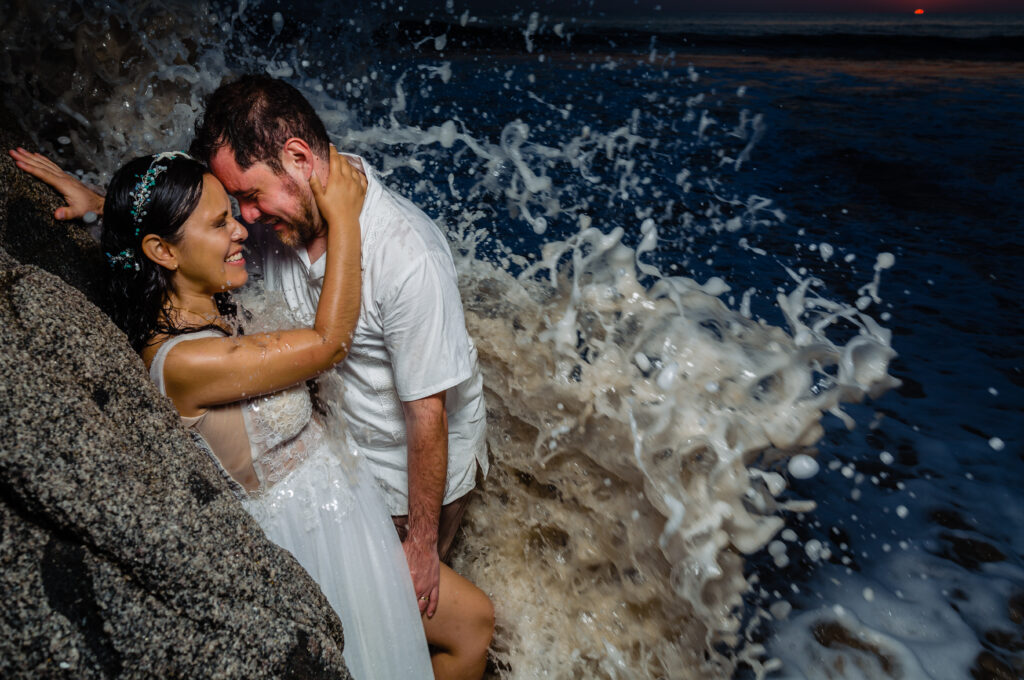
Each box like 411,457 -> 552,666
190,76 -> 487,617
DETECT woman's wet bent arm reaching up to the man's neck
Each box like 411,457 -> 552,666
164,146 -> 367,416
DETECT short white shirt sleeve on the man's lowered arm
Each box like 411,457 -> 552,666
381,250 -> 472,401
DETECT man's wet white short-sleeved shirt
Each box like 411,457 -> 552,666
248,156 -> 487,515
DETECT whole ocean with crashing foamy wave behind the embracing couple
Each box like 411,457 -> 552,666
0,0 -> 1024,680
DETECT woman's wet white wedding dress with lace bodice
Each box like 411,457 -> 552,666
150,331 -> 433,680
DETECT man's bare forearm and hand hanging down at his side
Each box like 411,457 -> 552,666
401,392 -> 447,619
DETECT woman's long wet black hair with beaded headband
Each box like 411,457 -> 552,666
100,154 -> 234,351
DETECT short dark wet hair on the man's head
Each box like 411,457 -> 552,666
189,74 -> 331,173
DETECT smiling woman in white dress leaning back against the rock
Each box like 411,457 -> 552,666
11,146 -> 493,679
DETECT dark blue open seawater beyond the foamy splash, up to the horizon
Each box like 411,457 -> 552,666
382,21 -> 1024,677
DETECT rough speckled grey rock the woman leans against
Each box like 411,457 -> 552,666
0,130 -> 349,678
